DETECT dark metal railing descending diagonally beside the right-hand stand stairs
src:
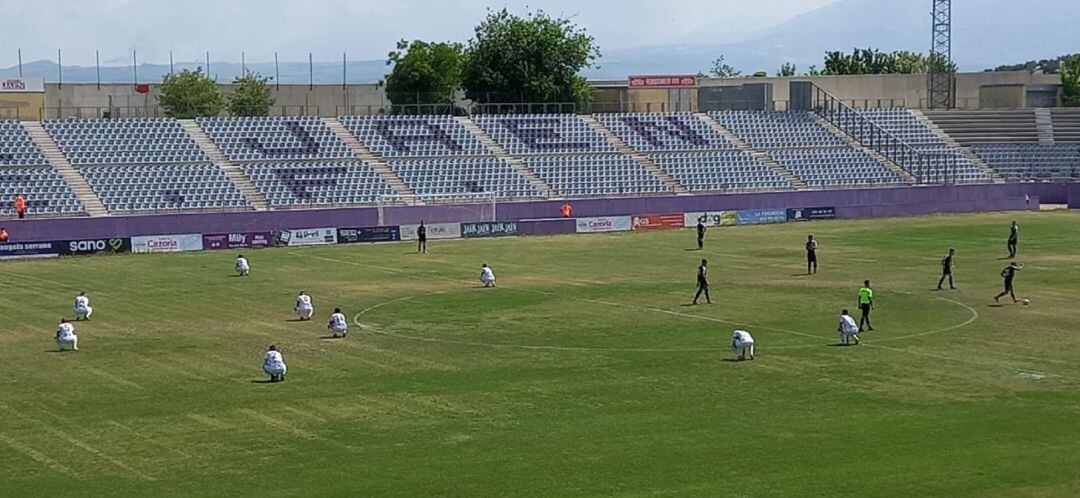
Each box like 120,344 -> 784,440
812,85 -> 957,184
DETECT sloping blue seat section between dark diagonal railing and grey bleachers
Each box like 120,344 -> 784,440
860,108 -> 990,183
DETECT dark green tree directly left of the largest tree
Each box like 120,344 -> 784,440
379,40 -> 465,105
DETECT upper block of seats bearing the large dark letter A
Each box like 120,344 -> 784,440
339,116 -> 491,158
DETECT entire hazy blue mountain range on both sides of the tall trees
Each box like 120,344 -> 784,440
0,0 -> 1080,84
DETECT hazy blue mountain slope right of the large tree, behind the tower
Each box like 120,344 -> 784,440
588,0 -> 1080,78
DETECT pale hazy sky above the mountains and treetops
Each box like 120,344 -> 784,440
0,0 -> 838,66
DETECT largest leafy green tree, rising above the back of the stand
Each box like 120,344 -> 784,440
461,9 -> 600,105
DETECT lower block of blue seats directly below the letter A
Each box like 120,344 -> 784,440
388,157 -> 541,199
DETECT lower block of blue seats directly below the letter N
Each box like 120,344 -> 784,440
649,150 -> 793,192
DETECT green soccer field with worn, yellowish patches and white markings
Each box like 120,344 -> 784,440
0,212 -> 1080,497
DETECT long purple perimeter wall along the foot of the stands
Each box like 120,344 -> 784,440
4,184 -> 1058,242
